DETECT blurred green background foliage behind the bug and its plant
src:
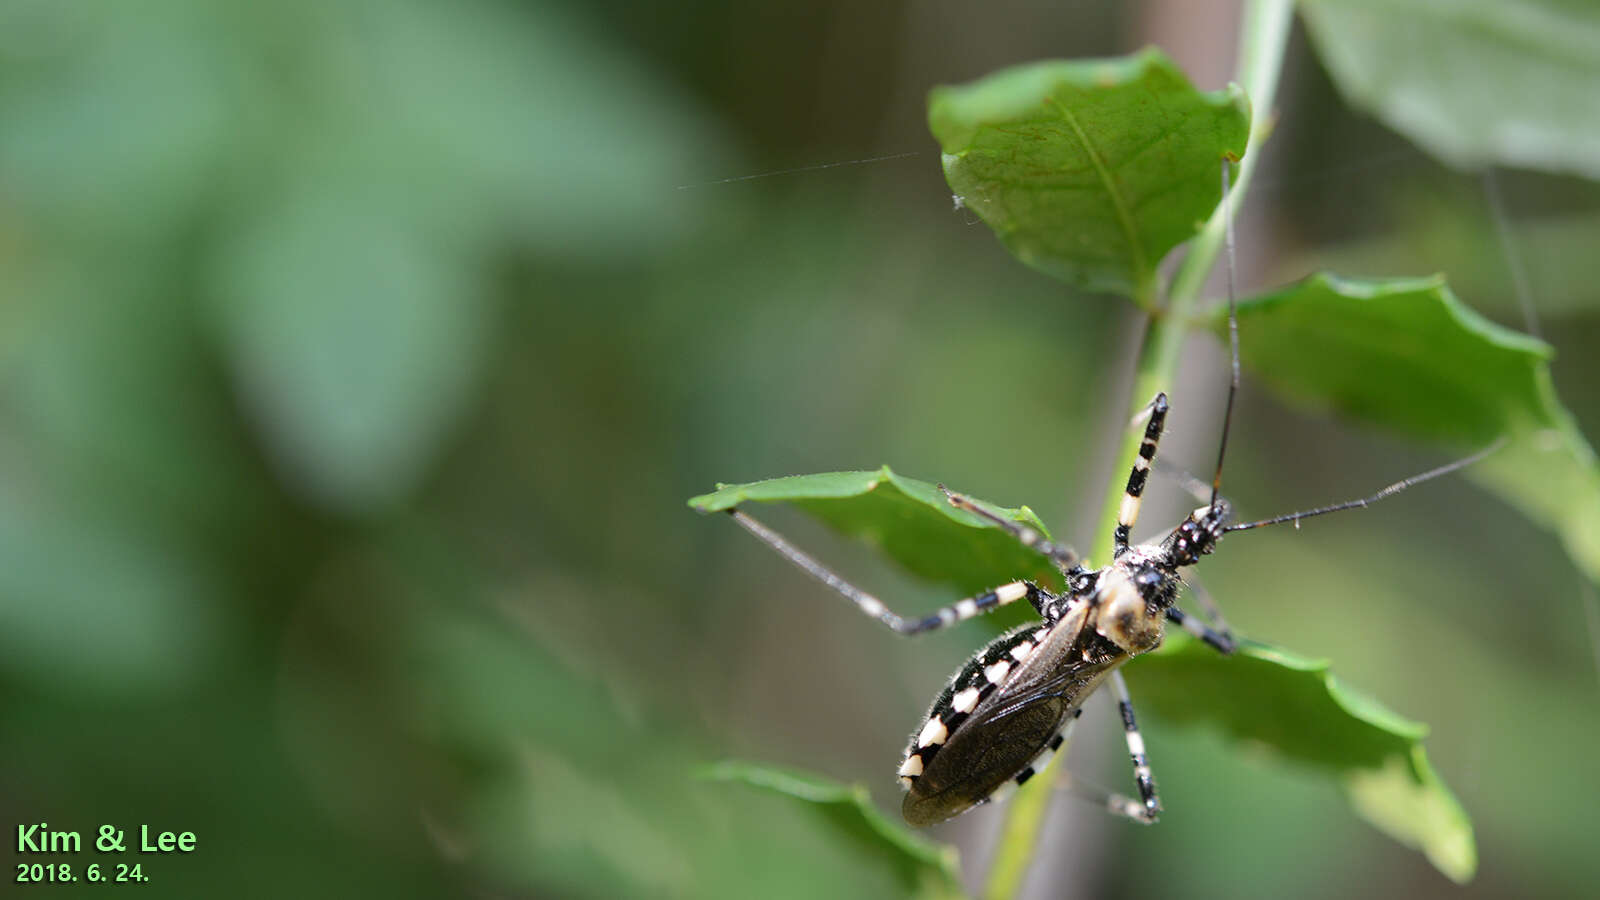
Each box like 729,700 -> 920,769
0,0 -> 1600,897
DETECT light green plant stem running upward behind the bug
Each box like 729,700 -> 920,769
984,0 -> 1293,900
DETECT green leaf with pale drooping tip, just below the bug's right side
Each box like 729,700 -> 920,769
1128,634 -> 1477,881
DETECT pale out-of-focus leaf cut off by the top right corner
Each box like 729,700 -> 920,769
1301,0 -> 1600,178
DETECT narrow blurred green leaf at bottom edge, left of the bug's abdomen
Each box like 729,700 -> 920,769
701,761 -> 966,900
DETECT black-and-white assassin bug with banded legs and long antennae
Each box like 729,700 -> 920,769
707,163 -> 1499,826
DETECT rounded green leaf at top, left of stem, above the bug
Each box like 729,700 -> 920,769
928,50 -> 1250,296
